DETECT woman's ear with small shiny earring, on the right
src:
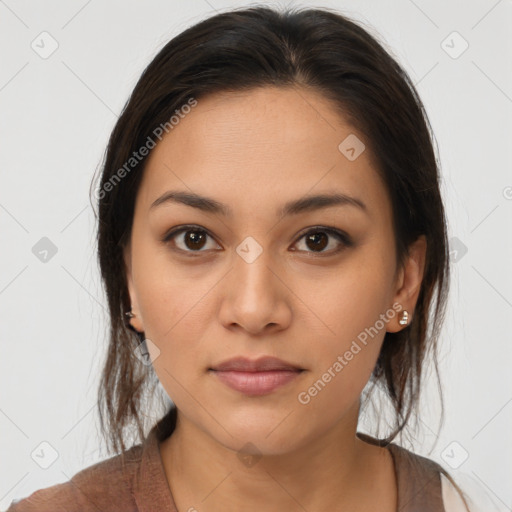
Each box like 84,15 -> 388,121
386,235 -> 427,332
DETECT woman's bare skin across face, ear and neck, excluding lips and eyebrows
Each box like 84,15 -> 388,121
125,87 -> 426,512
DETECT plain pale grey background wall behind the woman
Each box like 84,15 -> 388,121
0,0 -> 512,510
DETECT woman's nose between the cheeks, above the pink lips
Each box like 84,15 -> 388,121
219,251 -> 293,335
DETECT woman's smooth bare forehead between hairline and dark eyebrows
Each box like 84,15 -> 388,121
136,87 -> 389,220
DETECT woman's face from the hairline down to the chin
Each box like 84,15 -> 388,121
125,87 -> 422,454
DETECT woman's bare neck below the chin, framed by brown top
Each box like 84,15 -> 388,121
160,409 -> 392,512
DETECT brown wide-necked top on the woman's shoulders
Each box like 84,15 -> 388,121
6,409 -> 460,512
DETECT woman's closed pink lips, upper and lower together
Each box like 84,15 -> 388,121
210,357 -> 303,396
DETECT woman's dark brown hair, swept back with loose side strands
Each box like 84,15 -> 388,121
92,6 -> 464,500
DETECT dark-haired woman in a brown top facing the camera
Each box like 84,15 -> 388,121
9,7 -> 476,512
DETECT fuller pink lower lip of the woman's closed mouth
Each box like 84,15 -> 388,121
213,370 -> 301,396
